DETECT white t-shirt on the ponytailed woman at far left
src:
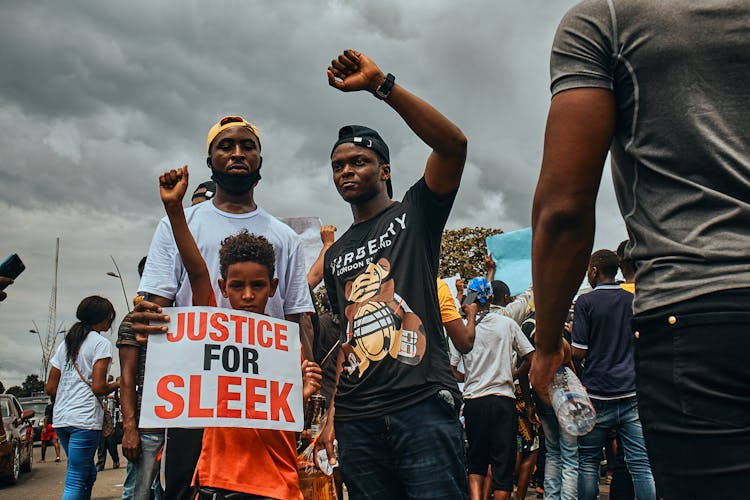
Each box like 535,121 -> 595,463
50,331 -> 112,430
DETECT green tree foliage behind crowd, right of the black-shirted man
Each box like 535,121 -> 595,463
440,227 -> 503,280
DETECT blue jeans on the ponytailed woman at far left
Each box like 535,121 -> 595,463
55,427 -> 102,500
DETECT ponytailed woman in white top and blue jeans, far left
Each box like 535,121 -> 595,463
46,296 -> 119,500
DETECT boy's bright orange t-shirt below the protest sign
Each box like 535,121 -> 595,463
193,294 -> 303,500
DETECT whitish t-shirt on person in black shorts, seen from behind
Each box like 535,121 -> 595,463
450,312 -> 534,399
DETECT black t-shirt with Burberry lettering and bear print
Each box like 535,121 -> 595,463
325,178 -> 459,420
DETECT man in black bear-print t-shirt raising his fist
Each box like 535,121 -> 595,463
318,50 -> 471,499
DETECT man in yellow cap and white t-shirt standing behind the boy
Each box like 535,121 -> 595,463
130,116 -> 313,500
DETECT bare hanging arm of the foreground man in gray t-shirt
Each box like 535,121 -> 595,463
531,89 -> 616,397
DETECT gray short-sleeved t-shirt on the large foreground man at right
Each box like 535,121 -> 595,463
550,0 -> 750,313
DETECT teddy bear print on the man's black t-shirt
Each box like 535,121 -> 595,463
341,258 -> 427,377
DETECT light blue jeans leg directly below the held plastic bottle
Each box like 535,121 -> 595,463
537,403 -> 578,500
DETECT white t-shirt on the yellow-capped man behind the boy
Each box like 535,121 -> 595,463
138,201 -> 313,318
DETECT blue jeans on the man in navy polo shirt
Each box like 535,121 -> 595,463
578,396 -> 656,500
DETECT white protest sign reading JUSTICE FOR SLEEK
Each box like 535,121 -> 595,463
139,307 -> 304,431
